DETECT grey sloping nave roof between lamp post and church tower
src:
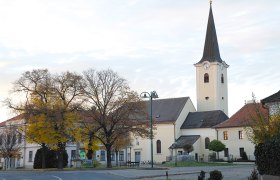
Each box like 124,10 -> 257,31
146,97 -> 189,122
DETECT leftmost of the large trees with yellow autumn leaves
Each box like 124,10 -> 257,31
5,69 -> 51,168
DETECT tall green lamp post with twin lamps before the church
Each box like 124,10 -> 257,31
140,91 -> 158,168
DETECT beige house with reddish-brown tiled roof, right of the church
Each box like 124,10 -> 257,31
215,101 -> 267,160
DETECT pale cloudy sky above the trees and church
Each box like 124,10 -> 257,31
0,0 -> 280,122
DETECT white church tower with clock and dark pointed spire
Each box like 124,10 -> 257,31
194,1 -> 229,115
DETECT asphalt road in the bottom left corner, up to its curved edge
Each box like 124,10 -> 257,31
0,171 -> 128,180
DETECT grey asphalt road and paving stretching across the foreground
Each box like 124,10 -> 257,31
0,164 -> 255,180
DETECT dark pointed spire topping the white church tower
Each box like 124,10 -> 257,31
198,1 -> 223,63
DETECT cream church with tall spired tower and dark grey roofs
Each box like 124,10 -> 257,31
128,3 -> 229,163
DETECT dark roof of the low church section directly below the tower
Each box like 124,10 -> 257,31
181,110 -> 228,129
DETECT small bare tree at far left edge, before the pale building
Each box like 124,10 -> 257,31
0,124 -> 22,168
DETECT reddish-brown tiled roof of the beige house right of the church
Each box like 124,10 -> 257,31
215,103 -> 268,128
